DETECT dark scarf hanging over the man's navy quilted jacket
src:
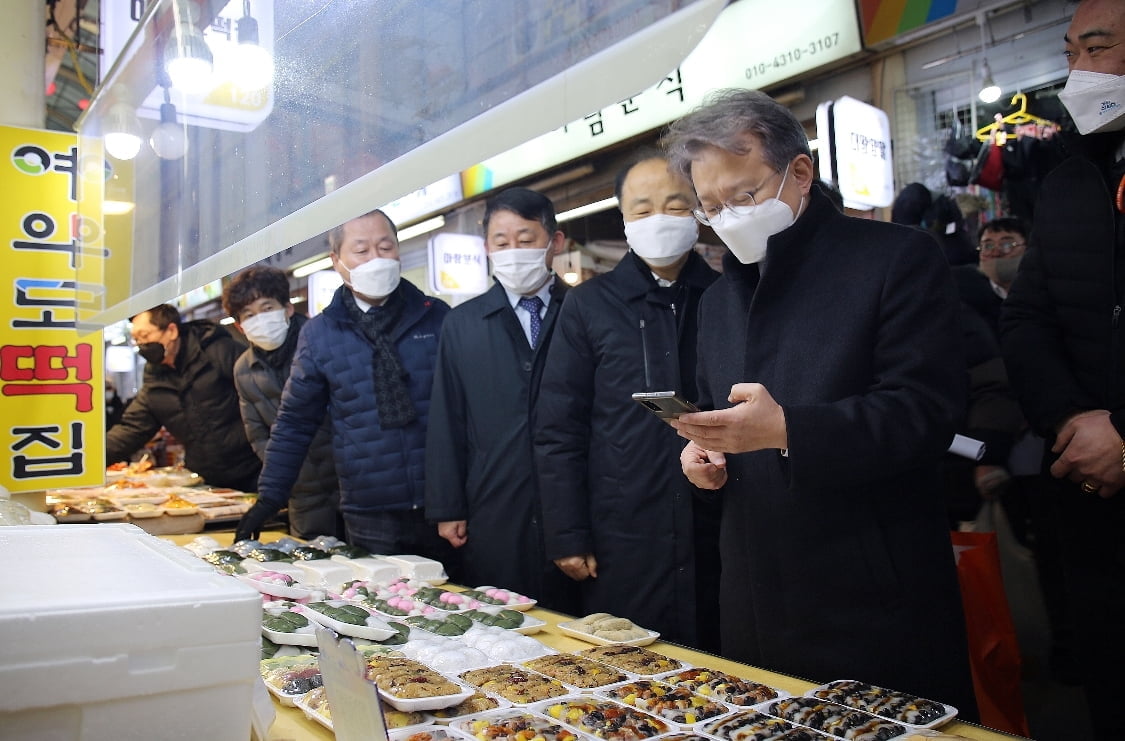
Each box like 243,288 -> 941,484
344,289 -> 419,430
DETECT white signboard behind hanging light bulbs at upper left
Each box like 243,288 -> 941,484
99,0 -> 273,132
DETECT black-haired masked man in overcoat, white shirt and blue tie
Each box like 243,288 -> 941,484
425,188 -> 575,612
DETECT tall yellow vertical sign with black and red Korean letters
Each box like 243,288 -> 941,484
0,126 -> 106,491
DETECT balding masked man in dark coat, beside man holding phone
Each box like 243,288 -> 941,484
534,153 -> 718,647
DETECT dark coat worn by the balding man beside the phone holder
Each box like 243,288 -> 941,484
534,253 -> 716,642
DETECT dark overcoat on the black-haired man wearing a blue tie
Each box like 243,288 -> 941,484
425,278 -> 566,602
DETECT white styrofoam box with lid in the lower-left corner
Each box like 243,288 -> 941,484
0,524 -> 261,741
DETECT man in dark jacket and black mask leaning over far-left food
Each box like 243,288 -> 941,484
106,304 -> 262,491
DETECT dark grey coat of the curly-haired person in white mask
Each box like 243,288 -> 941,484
234,314 -> 340,540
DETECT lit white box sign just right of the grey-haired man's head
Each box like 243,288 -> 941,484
817,96 -> 894,210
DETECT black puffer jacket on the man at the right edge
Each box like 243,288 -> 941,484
1000,136 -> 1125,439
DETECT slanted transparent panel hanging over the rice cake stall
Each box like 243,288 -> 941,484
78,0 -> 726,326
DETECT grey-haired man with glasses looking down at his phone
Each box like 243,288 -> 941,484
666,90 -> 975,717
